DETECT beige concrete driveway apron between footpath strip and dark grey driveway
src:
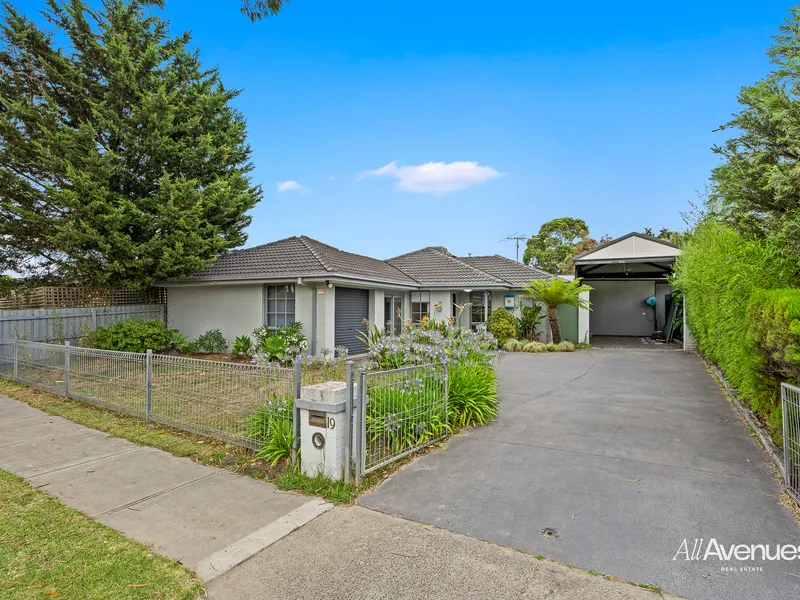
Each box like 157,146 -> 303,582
207,506 -> 675,600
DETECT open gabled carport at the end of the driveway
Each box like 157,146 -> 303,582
574,233 -> 680,337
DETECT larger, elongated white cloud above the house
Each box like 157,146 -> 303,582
356,160 -> 502,194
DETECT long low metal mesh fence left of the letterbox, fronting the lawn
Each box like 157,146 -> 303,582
0,340 -> 299,449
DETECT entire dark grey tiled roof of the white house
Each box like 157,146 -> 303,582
167,236 -> 552,287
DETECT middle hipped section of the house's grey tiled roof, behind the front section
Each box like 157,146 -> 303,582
386,247 -> 505,286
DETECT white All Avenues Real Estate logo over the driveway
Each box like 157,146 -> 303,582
672,538 -> 800,573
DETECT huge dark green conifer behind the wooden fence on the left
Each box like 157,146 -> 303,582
0,0 -> 261,286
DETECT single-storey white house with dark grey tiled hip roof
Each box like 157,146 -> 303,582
159,236 -> 552,354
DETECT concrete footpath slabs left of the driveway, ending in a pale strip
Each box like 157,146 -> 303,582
0,395 -> 331,581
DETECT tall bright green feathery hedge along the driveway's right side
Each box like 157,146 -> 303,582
674,221 -> 797,435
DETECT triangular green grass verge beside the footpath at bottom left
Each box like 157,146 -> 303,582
0,471 -> 203,600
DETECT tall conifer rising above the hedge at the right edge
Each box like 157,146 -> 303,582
710,7 -> 800,258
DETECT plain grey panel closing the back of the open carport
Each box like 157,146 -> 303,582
584,281 -> 655,336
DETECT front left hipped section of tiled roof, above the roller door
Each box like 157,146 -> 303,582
170,236 -> 416,285
